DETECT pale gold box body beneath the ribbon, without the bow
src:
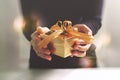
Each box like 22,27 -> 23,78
53,38 -> 72,58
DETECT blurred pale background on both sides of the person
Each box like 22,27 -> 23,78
0,0 -> 120,79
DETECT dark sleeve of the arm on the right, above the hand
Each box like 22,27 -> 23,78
79,0 -> 103,35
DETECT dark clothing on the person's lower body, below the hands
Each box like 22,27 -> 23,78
30,45 -> 97,69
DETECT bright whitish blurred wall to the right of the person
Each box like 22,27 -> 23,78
97,0 -> 120,67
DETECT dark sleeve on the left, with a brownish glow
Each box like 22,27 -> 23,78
20,0 -> 37,41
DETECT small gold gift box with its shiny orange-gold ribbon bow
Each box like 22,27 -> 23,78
39,20 -> 93,58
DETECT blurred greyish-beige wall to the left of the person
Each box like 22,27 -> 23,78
0,0 -> 29,69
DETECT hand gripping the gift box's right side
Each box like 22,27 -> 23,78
71,24 -> 92,57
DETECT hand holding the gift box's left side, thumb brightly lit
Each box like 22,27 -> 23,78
31,27 -> 52,61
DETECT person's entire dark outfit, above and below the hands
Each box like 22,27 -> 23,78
21,0 -> 103,68
